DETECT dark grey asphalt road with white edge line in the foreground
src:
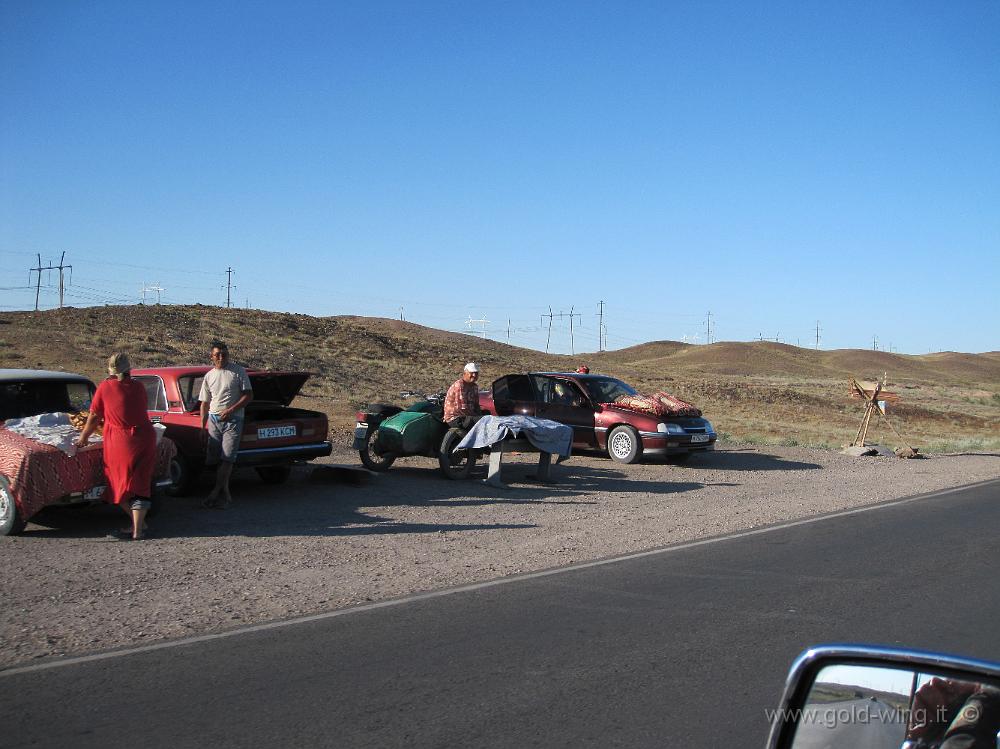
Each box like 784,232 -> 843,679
0,482 -> 1000,747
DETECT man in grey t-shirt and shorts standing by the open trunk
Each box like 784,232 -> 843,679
198,341 -> 253,510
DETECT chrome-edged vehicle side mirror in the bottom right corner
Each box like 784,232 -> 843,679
768,646 -> 1000,749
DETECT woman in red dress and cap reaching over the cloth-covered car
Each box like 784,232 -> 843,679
76,353 -> 156,540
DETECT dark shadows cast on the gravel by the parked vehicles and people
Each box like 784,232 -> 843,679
23,450 -> 705,543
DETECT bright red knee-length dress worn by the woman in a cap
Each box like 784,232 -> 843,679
90,377 -> 156,504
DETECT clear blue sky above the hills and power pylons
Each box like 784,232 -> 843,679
0,0 -> 1000,353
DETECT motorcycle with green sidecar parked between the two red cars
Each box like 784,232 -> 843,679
352,391 -> 484,479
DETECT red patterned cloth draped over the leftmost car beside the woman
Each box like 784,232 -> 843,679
0,427 -> 177,520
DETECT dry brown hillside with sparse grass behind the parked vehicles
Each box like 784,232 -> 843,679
0,305 -> 1000,451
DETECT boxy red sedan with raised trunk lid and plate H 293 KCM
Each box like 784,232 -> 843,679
132,366 -> 333,494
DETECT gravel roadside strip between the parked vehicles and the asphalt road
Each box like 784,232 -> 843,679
0,443 -> 1000,668
